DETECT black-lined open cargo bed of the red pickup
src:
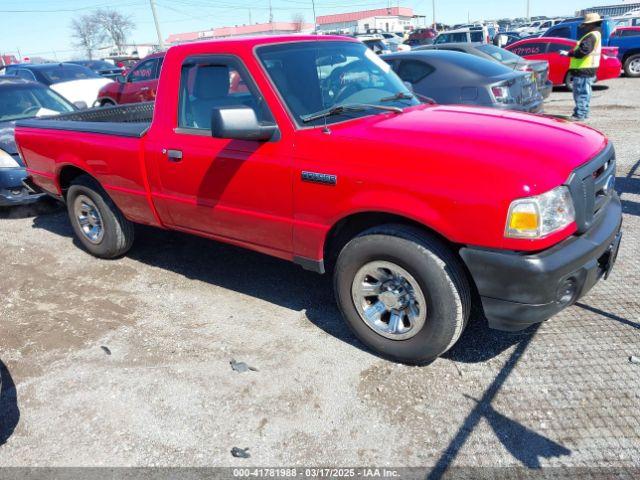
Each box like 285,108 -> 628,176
17,102 -> 154,138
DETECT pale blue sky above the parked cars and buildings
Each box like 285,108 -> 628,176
0,0 -> 618,60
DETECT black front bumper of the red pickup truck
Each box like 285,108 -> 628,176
460,195 -> 622,331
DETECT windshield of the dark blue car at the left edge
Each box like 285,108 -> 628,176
0,85 -> 74,122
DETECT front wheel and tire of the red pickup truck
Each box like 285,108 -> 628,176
334,225 -> 471,365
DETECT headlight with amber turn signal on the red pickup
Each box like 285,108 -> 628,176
505,186 -> 576,238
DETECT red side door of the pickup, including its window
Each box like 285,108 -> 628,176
148,55 -> 293,257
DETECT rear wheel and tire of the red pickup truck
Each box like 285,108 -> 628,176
66,175 -> 134,259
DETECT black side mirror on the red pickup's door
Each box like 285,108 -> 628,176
211,107 -> 278,142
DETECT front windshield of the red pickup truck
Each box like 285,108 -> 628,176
258,40 -> 420,125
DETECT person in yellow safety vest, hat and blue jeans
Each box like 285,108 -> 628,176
561,13 -> 602,121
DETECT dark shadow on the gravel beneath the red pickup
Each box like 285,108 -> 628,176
33,211 -> 527,363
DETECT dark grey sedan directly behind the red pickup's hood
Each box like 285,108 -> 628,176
382,50 -> 544,113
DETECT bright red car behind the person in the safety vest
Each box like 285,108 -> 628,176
506,37 -> 621,90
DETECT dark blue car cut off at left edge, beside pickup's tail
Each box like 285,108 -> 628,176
0,77 -> 77,207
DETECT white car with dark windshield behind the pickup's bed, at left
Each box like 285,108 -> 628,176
0,63 -> 112,108
